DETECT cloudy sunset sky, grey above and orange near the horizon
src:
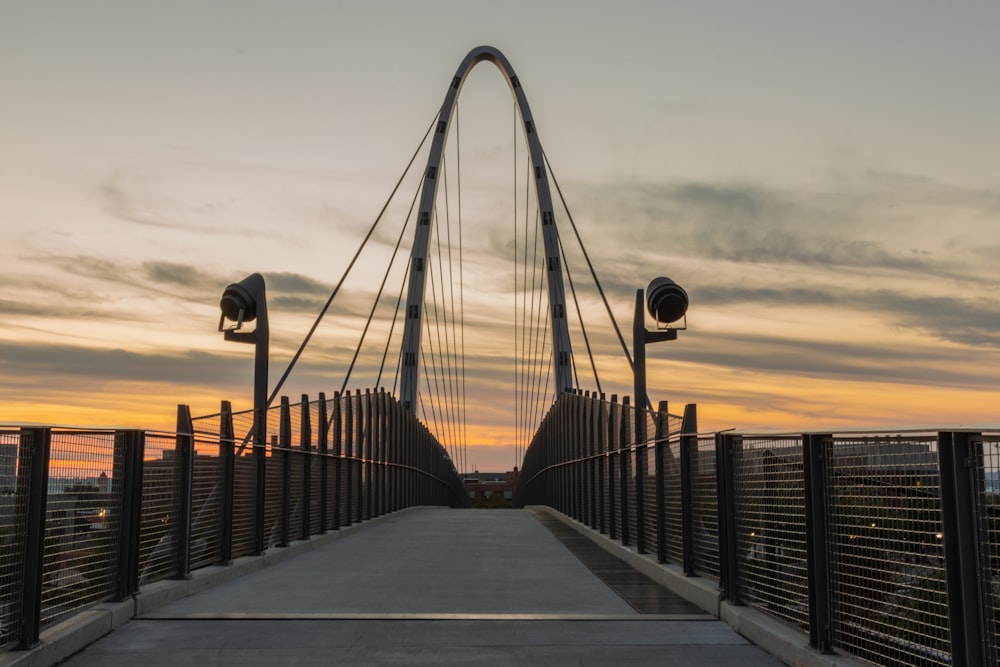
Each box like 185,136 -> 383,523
0,0 -> 1000,469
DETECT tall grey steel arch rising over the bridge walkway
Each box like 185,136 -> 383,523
399,46 -> 573,412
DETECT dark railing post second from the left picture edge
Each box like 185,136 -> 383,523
115,430 -> 146,601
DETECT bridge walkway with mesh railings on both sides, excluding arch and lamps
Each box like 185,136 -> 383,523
0,400 -> 1000,665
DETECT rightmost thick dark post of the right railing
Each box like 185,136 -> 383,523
938,431 -> 997,665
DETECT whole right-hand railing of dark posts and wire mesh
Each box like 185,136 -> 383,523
515,393 -> 1000,665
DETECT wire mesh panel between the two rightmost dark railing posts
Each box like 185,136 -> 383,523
829,437 -> 951,665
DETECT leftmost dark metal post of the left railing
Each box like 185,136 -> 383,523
17,428 -> 52,649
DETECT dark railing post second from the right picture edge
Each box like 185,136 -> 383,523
802,433 -> 833,653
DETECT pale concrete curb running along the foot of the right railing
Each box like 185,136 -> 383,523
526,505 -> 866,667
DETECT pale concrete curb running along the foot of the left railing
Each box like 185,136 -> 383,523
0,507 -> 420,667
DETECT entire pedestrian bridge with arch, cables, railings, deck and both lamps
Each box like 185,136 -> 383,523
0,47 -> 1000,666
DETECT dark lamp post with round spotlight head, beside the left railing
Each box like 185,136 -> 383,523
219,273 -> 268,554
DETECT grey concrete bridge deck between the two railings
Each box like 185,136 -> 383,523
66,508 -> 781,667
